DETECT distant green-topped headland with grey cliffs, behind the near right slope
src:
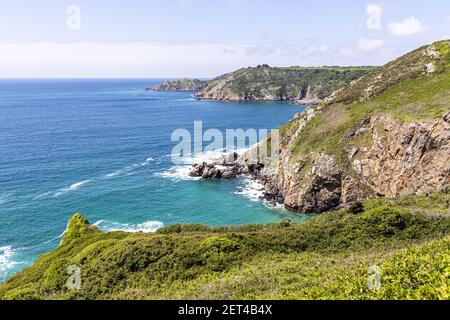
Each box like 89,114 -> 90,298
197,65 -> 372,103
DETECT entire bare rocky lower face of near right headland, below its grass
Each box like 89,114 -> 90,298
263,113 -> 450,212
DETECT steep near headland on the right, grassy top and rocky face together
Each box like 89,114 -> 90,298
241,41 -> 450,212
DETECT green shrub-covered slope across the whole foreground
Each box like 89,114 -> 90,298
0,190 -> 450,299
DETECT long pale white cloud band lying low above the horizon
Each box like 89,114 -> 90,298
0,40 -> 395,78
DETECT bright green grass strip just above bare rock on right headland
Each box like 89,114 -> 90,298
290,60 -> 450,169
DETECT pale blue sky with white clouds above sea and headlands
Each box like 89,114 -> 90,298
0,0 -> 450,78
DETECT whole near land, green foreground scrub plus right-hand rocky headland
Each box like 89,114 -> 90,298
0,41 -> 450,300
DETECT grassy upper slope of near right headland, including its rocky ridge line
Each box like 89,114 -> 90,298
281,41 -> 450,166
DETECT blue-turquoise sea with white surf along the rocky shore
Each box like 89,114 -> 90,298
0,80 -> 308,282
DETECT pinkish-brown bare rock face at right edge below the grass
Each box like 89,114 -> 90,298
353,115 -> 450,197
